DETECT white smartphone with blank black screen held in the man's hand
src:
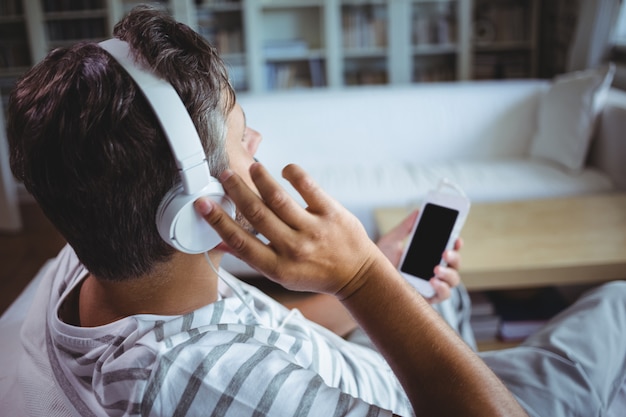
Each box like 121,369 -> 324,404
399,191 -> 470,298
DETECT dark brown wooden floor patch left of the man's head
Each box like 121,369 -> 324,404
0,202 -> 65,314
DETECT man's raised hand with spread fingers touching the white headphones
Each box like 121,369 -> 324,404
196,163 -> 388,299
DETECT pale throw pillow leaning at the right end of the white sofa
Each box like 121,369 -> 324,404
530,64 -> 615,171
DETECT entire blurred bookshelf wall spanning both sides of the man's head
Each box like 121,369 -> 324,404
0,0 -> 540,94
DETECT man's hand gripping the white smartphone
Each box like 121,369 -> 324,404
377,211 -> 463,304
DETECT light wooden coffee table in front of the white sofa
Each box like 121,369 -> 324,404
375,193 -> 626,290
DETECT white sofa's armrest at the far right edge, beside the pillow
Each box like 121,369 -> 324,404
589,88 -> 626,190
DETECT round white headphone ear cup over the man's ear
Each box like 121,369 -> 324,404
156,178 -> 235,254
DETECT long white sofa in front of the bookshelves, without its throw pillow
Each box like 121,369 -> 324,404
224,72 -> 626,275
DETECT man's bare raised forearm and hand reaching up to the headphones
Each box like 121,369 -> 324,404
196,164 -> 526,416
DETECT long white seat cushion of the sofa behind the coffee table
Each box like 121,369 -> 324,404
305,158 -> 614,238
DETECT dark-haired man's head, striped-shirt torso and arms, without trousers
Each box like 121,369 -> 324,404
9,4 -> 623,416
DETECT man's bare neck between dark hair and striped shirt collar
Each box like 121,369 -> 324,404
78,253 -> 222,327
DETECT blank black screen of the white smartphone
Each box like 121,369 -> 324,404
400,203 -> 459,279
